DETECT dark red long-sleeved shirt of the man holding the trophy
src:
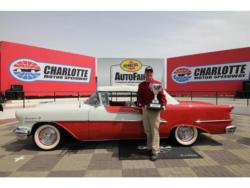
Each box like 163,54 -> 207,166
137,80 -> 167,107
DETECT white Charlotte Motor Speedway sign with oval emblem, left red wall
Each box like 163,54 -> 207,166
9,59 -> 91,83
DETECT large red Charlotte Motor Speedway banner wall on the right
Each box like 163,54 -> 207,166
166,47 -> 250,95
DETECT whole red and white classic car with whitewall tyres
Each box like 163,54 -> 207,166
15,86 -> 236,150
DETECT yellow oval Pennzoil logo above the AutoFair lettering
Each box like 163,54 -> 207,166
120,59 -> 142,72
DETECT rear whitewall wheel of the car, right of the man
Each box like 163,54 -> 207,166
174,126 -> 199,146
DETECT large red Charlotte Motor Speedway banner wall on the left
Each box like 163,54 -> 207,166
0,42 -> 96,96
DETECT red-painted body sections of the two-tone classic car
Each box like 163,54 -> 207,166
55,101 -> 232,140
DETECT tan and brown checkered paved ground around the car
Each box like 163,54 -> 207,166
0,115 -> 250,177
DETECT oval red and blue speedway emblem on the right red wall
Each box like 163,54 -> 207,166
172,67 -> 192,84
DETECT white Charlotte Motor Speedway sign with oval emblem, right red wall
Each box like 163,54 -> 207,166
171,62 -> 250,84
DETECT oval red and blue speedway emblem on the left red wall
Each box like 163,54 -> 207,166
10,59 -> 41,81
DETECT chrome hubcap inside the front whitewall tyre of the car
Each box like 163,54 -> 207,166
39,127 -> 57,146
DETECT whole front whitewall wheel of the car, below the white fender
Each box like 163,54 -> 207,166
33,124 -> 63,150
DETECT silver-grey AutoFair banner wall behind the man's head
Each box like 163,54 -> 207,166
97,58 -> 166,86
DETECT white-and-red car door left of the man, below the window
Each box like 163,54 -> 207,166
89,90 -> 144,140
